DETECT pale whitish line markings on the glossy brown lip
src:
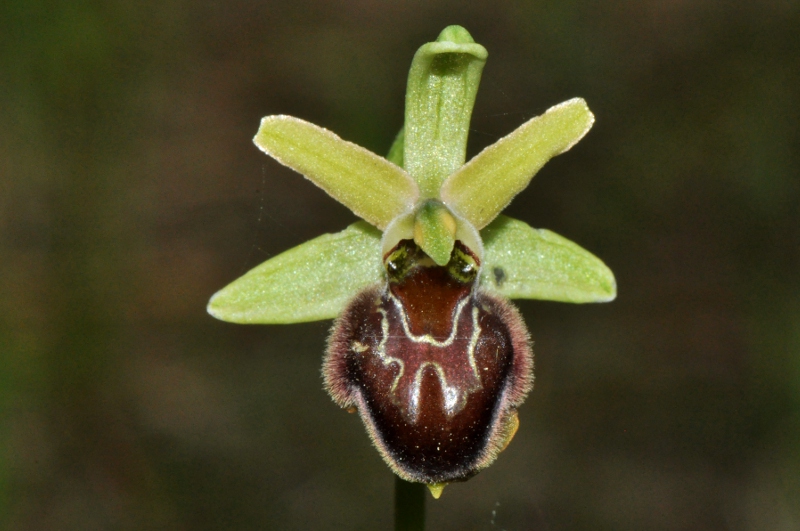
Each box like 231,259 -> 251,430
352,293 -> 481,421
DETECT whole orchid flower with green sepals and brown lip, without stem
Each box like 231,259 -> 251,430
208,26 -> 616,496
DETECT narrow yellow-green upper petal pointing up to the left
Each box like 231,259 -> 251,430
253,116 -> 419,229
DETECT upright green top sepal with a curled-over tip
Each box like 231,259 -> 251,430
403,26 -> 488,198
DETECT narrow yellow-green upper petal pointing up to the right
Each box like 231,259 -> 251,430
441,98 -> 594,229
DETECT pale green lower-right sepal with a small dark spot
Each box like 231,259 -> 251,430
481,216 -> 617,302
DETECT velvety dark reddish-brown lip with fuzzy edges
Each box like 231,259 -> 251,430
324,240 -> 533,484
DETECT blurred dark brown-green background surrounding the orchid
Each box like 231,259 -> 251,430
0,0 -> 800,531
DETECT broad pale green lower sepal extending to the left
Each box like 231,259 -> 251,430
208,221 -> 384,324
